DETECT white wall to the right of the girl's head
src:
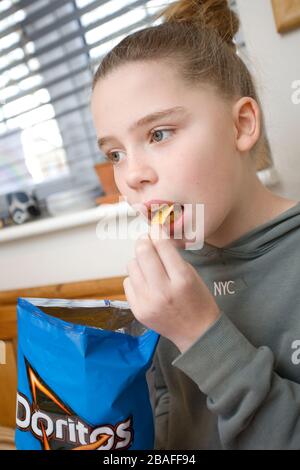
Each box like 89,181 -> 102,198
237,0 -> 300,200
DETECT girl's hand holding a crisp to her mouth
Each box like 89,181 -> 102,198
123,227 -> 220,352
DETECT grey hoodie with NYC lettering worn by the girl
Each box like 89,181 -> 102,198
152,202 -> 300,450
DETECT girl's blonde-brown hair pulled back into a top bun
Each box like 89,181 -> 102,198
93,0 -> 266,162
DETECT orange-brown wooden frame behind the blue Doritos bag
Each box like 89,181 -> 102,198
0,276 -> 126,434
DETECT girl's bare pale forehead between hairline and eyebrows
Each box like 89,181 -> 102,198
92,62 -> 229,135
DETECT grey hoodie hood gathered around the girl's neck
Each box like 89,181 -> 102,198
180,201 -> 300,261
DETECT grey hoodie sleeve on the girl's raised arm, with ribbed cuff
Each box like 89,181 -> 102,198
172,312 -> 300,450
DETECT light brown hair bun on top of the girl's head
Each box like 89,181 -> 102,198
158,0 -> 240,48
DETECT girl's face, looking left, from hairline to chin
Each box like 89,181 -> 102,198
92,61 -> 246,245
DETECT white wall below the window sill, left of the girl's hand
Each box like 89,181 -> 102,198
0,222 -> 134,291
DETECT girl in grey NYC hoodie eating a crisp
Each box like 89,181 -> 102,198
92,0 -> 300,449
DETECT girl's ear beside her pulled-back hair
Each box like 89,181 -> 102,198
233,96 -> 261,152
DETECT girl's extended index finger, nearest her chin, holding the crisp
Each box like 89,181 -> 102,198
150,222 -> 186,281
